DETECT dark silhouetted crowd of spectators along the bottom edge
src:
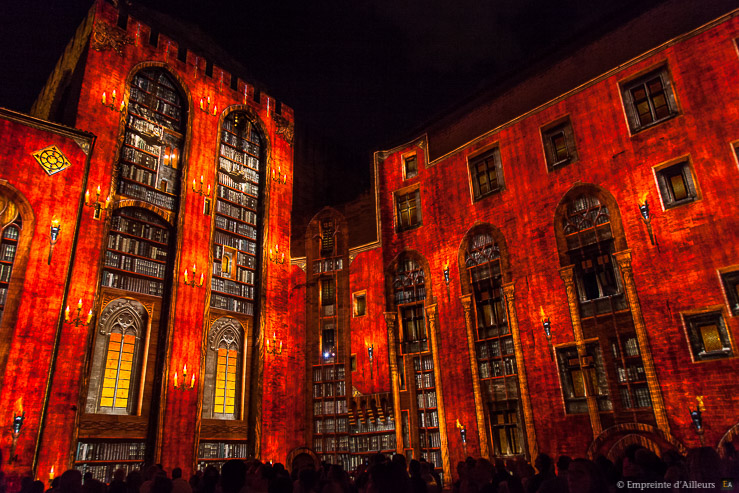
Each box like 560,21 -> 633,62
5,445 -> 739,493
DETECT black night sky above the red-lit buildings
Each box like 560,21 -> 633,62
0,0 -> 659,198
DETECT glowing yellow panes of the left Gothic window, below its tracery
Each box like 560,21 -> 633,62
100,333 -> 136,409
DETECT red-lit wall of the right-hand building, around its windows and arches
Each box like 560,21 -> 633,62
372,14 -> 739,464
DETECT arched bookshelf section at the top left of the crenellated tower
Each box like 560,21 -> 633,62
118,67 -> 187,211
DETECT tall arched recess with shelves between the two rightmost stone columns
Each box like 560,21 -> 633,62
555,190 -> 654,418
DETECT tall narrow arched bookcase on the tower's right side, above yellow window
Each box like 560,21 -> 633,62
210,112 -> 264,315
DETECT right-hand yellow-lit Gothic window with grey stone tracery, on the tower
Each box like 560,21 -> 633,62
203,317 -> 244,419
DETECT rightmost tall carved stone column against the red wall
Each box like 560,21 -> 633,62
613,250 -> 670,436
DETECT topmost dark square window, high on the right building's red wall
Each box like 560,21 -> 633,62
621,67 -> 677,132
